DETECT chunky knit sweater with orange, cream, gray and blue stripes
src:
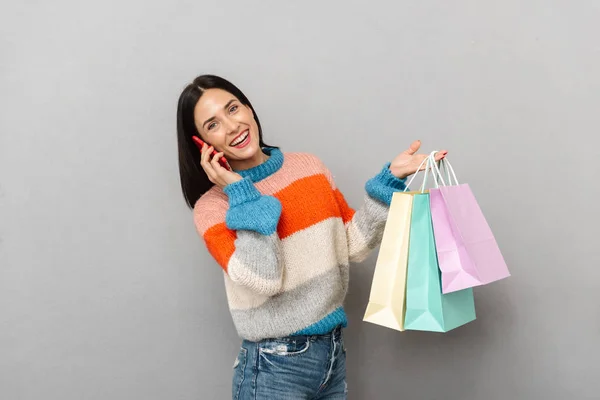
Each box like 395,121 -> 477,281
194,147 -> 405,341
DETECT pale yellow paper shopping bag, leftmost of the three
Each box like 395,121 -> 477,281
363,192 -> 412,331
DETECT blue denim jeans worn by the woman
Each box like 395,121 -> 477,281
232,327 -> 347,400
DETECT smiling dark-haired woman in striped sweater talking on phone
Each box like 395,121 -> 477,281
177,75 -> 446,399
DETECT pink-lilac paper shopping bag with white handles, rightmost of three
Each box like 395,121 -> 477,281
429,159 -> 510,293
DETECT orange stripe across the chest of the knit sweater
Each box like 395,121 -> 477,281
274,174 -> 342,239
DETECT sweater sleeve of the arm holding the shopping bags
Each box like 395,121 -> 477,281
323,163 -> 406,262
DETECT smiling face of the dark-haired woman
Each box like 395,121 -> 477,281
194,89 -> 261,169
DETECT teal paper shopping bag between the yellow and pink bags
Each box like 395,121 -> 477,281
404,193 -> 475,332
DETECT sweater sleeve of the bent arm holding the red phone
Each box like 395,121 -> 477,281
194,178 -> 283,296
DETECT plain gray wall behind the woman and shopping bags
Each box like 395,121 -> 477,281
0,0 -> 600,400
